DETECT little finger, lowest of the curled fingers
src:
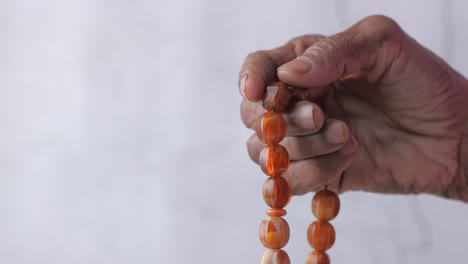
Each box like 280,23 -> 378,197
283,137 -> 358,195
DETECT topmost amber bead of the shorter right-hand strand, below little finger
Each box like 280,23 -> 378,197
312,190 -> 340,221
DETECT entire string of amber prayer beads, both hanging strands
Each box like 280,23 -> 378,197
256,82 -> 340,264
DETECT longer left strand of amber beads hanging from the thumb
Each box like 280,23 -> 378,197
256,83 -> 292,264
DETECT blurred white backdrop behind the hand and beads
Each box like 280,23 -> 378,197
0,0 -> 468,264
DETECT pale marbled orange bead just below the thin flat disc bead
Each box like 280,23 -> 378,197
259,217 -> 289,249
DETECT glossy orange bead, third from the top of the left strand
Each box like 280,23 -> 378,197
259,145 -> 290,177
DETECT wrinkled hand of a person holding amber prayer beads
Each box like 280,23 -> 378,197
239,16 -> 468,201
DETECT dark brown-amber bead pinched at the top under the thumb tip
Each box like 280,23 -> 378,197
263,82 -> 292,112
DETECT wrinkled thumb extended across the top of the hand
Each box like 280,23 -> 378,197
278,16 -> 404,88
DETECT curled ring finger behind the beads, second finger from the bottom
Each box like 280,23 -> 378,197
247,119 -> 349,164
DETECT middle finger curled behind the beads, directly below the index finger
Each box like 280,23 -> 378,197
241,99 -> 325,136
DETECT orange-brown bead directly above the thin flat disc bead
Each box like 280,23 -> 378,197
263,177 -> 292,209
